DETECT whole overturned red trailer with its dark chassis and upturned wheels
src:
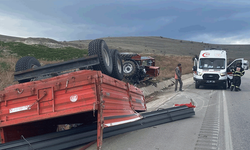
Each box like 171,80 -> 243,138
0,39 -> 146,149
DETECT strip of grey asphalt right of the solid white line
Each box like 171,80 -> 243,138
225,70 -> 250,150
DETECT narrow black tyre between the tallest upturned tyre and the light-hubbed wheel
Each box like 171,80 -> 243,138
110,49 -> 123,80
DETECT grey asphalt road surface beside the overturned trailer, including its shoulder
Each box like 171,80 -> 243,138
87,70 -> 250,150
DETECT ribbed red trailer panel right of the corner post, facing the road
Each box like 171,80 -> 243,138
101,75 -> 146,127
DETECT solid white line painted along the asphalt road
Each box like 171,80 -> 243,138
222,90 -> 233,150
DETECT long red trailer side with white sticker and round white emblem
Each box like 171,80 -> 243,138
0,70 -> 98,127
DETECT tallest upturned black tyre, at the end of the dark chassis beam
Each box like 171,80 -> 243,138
88,39 -> 113,75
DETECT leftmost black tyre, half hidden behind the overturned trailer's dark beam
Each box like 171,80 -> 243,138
15,56 -> 41,72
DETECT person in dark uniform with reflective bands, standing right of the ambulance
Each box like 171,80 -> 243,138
231,63 -> 245,91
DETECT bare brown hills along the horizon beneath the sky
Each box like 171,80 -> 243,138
0,35 -> 250,60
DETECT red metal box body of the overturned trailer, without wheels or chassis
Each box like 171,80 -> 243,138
0,70 -> 146,149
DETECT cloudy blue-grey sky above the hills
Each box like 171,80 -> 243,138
0,0 -> 250,44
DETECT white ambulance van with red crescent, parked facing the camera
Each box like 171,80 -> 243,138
193,49 -> 227,89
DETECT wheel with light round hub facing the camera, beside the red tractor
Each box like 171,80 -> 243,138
123,60 -> 138,78
